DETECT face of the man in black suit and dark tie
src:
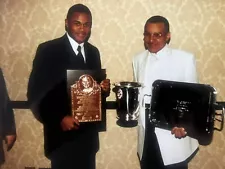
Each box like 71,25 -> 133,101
65,12 -> 92,44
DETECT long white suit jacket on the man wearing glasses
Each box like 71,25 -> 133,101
133,45 -> 198,165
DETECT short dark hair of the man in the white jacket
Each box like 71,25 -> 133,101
145,15 -> 170,33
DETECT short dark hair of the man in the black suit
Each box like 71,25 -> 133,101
66,4 -> 92,20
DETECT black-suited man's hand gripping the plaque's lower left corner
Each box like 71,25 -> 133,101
61,116 -> 80,131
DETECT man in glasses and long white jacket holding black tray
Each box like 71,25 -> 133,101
133,16 -> 198,169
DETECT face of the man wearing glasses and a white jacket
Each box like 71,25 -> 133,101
143,22 -> 170,53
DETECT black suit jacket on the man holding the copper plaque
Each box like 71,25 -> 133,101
27,35 -> 101,157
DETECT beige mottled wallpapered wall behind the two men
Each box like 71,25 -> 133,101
0,0 -> 225,169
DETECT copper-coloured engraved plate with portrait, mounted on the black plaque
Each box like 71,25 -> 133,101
70,74 -> 102,122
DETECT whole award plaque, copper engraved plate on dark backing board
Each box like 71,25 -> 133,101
67,70 -> 105,122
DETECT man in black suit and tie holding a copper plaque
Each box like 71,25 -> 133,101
27,4 -> 110,169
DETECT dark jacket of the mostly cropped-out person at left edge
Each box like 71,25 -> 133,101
0,69 -> 16,164
